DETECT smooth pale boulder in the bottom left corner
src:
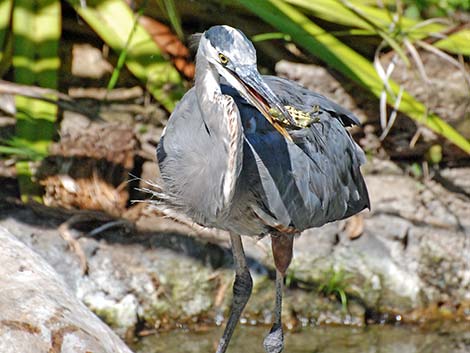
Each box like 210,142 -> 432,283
0,227 -> 131,353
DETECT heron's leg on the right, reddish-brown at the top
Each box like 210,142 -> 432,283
263,234 -> 294,353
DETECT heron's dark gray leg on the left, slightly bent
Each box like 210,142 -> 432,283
216,233 -> 253,353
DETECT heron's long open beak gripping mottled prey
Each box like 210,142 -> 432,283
231,69 -> 296,141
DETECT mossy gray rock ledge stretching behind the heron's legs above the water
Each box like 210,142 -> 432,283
0,162 -> 470,336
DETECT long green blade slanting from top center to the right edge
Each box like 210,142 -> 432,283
238,0 -> 470,154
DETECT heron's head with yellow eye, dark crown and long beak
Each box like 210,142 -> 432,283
198,26 -> 296,139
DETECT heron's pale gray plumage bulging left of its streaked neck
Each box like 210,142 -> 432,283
157,88 -> 239,226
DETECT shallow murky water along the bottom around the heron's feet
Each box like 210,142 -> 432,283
133,323 -> 470,353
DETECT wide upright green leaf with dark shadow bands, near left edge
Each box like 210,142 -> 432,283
13,0 -> 61,200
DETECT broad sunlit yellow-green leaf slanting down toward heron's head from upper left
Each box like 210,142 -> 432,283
69,0 -> 184,111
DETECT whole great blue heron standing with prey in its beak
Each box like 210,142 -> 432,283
157,26 -> 369,353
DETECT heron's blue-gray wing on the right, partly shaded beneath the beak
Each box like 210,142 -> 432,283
223,76 -> 369,230
